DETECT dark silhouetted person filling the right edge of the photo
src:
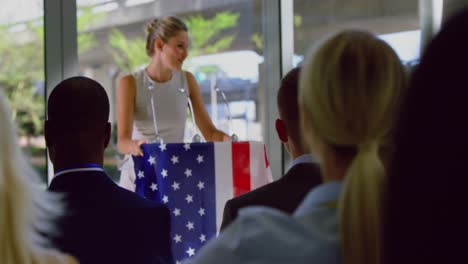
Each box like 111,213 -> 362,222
384,9 -> 468,263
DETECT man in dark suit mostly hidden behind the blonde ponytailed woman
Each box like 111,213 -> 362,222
221,68 -> 321,230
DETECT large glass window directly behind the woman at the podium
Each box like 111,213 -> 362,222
77,0 -> 265,181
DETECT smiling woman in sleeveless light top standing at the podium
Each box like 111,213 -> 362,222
117,16 -> 229,190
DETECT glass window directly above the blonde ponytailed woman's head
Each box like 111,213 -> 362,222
294,0 -> 421,64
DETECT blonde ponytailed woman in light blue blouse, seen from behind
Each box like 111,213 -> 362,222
190,31 -> 406,264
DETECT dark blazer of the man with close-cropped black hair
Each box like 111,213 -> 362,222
48,171 -> 173,264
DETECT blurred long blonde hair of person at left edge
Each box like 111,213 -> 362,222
0,92 -> 77,264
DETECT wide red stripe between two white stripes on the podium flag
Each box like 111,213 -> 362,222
232,142 -> 250,197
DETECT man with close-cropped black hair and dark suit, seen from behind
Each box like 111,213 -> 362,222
45,77 -> 173,263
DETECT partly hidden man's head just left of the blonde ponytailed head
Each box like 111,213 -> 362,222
275,68 -> 308,159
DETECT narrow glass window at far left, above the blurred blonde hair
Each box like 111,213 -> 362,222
0,0 -> 47,183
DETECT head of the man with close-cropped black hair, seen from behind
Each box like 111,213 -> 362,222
45,77 -> 110,169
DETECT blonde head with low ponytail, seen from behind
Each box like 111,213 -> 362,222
299,31 -> 406,264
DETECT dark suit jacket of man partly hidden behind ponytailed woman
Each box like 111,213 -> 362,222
221,163 -> 322,230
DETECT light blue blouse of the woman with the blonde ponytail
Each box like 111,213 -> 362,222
189,182 -> 342,264
